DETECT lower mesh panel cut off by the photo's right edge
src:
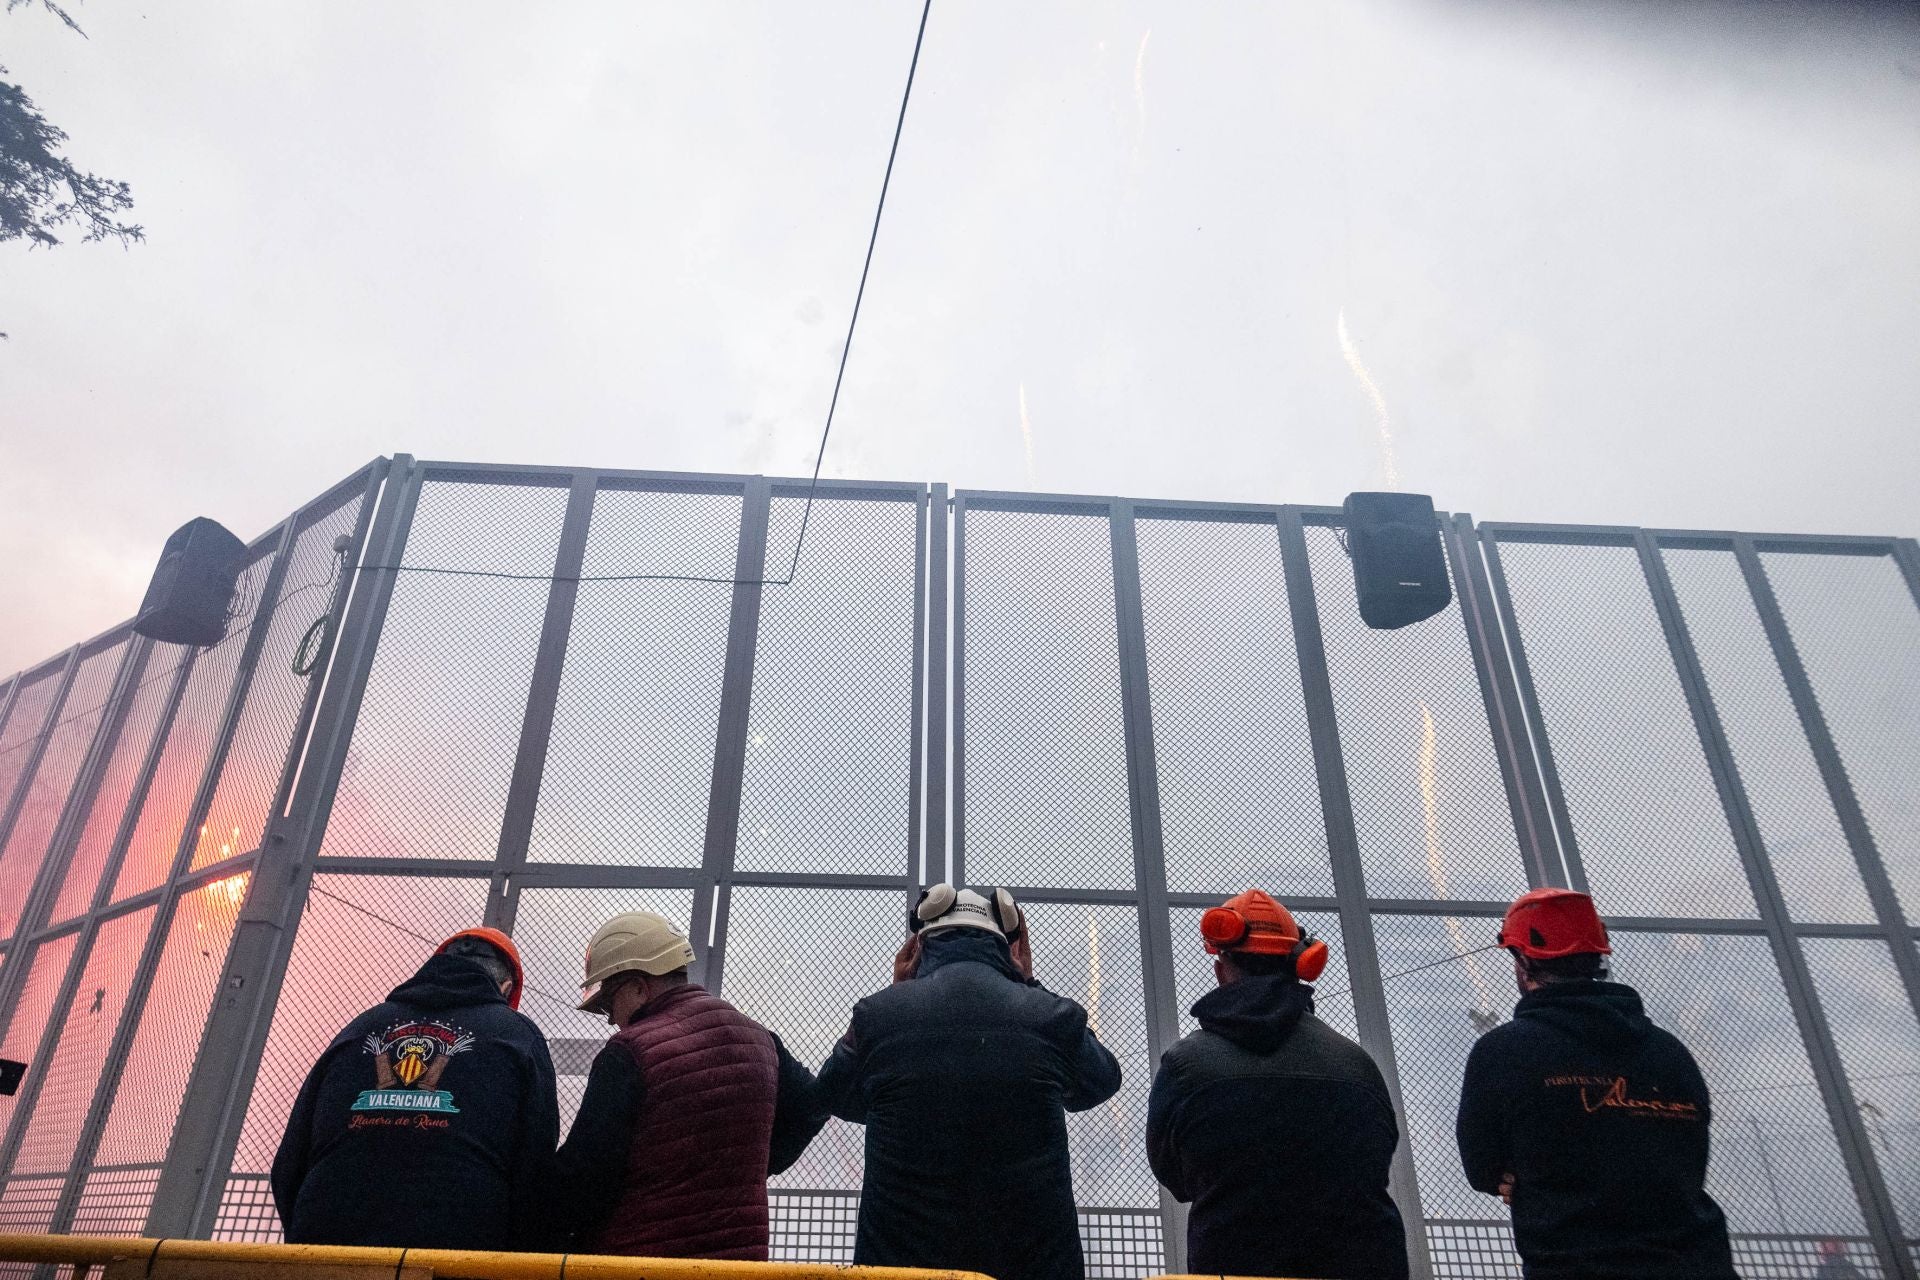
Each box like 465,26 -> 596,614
1801,938 -> 1920,1242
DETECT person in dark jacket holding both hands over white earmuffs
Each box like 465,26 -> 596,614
820,885 -> 1119,1280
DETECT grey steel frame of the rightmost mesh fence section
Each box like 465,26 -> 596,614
1463,522 -> 1920,1276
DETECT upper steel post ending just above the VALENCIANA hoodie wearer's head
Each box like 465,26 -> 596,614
486,472 -> 599,933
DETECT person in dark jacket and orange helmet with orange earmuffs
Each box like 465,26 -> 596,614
1146,889 -> 1407,1280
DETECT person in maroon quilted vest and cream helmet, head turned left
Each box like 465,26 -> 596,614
553,912 -> 826,1263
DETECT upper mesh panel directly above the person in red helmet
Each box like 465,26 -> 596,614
1500,543 -> 1755,917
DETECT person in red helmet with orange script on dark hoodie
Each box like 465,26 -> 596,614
1457,889 -> 1734,1280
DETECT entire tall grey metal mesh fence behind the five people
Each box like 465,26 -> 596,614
0,462 -> 1920,1280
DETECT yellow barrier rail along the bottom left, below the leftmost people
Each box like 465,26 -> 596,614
0,1236 -> 991,1280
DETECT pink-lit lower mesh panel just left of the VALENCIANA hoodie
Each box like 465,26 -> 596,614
221,875 -> 488,1217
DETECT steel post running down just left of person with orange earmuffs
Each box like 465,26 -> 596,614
1108,499 -> 1187,1272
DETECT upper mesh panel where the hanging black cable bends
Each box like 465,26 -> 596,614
733,497 -> 920,875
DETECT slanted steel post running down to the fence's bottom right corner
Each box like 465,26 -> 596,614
1634,530 -> 1916,1280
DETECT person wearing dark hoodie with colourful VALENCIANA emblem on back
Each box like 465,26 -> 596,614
273,929 -> 561,1249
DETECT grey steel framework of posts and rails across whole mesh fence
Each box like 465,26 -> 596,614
0,455 -> 1920,1276
